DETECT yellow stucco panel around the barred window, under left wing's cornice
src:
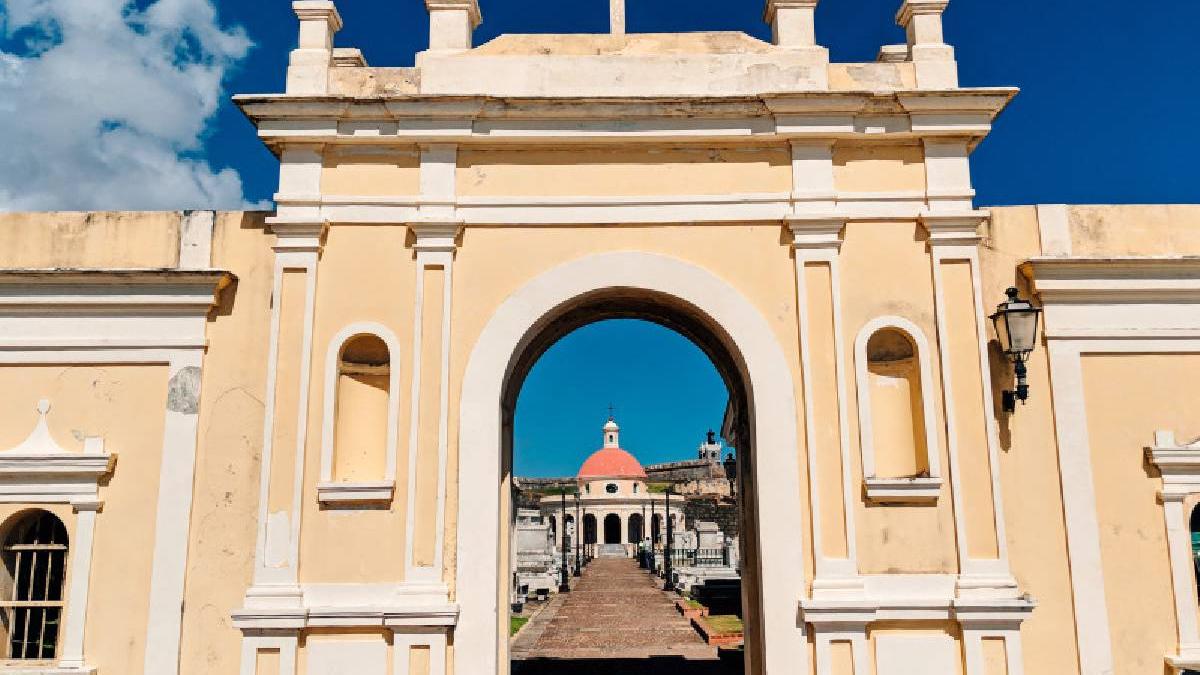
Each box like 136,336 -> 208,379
0,364 -> 167,674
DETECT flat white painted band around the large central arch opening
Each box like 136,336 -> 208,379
455,252 -> 809,675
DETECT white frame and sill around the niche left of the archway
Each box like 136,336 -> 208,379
317,322 -> 400,507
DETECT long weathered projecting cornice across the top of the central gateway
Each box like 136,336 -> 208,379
234,89 -> 1018,151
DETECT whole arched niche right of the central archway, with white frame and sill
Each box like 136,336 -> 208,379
856,317 -> 941,502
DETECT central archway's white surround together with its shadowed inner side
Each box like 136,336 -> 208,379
455,252 -> 809,675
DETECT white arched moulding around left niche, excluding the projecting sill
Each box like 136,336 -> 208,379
317,322 -> 401,502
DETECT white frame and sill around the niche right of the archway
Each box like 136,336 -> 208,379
854,316 -> 942,502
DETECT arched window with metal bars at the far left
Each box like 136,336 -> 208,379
0,510 -> 67,659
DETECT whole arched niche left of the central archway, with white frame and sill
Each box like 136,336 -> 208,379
317,323 -> 400,508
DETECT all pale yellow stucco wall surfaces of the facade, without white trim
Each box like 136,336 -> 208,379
0,176 -> 1200,675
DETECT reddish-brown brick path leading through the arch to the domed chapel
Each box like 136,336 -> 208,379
511,558 -> 721,675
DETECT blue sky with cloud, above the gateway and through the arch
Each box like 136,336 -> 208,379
0,0 -> 1200,474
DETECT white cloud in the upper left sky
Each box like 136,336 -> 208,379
0,0 -> 258,210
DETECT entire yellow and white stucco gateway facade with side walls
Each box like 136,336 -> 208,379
0,0 -> 1200,675
